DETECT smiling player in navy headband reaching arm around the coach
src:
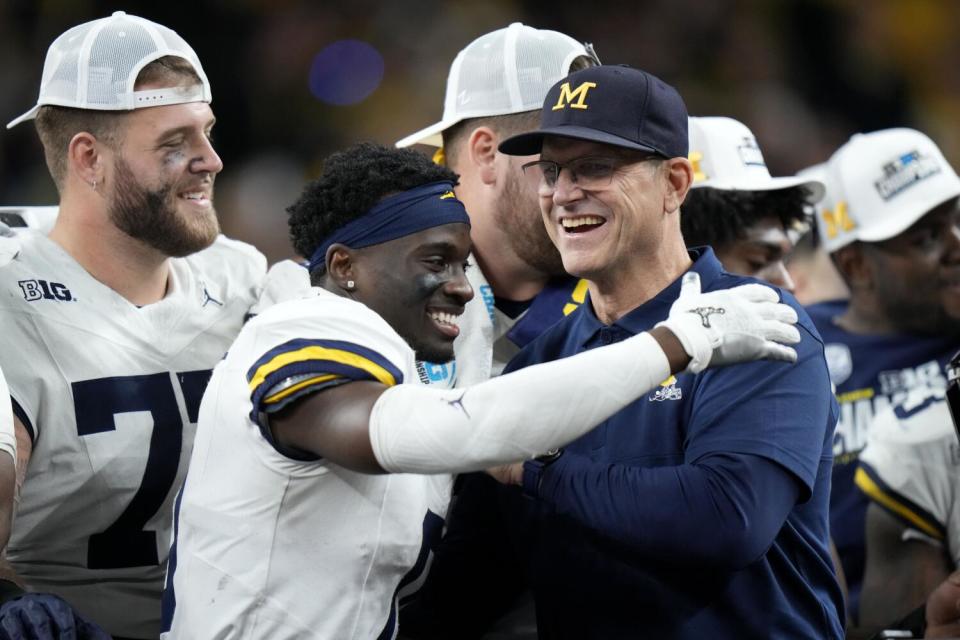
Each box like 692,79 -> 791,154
164,144 -> 799,640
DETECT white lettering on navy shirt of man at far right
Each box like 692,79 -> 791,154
833,360 -> 947,464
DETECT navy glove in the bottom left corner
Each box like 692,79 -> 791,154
0,593 -> 110,640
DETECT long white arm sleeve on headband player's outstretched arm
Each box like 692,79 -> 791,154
370,333 -> 670,473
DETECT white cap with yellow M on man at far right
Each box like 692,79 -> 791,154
817,129 -> 960,253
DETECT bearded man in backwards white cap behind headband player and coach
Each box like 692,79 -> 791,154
397,22 -> 597,385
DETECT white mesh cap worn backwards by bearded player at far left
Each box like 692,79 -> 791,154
7,11 -> 212,129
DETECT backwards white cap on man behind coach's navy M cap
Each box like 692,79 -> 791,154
397,22 -> 596,147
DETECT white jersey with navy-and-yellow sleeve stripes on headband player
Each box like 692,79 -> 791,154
163,289 -> 452,640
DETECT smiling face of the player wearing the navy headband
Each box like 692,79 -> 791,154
334,222 -> 473,362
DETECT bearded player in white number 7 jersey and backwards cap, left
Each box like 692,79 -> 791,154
0,12 -> 265,638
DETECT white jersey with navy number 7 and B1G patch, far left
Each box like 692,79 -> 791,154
0,230 -> 266,638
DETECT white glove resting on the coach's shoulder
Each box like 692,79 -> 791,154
657,271 -> 800,373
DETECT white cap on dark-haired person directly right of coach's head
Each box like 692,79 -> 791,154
687,116 -> 826,204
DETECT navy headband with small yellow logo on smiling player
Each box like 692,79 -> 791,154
310,181 -> 470,273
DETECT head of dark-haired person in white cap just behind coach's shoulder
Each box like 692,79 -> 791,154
680,117 -> 824,291
